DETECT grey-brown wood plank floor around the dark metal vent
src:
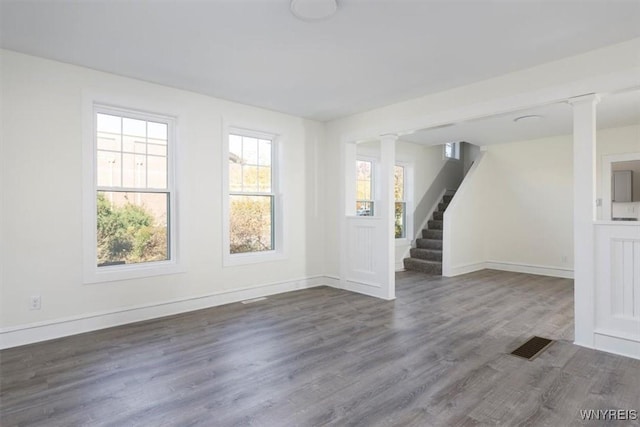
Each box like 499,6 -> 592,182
0,270 -> 640,427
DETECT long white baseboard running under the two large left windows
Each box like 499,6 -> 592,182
0,276 -> 339,349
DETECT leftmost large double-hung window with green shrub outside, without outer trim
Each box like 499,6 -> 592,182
94,106 -> 173,269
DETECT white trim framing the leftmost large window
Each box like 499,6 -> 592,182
82,101 -> 184,284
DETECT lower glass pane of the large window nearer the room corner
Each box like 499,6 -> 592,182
229,195 -> 274,254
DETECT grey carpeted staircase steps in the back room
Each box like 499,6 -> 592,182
403,195 -> 453,275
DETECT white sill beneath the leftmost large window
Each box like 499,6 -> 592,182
83,261 -> 186,284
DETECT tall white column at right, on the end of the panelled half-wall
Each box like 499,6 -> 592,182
569,94 -> 599,347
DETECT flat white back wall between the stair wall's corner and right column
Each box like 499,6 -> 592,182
486,136 -> 573,275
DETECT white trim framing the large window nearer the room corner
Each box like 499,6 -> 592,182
221,125 -> 287,267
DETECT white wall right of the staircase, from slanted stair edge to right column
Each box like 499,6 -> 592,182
443,136 -> 573,277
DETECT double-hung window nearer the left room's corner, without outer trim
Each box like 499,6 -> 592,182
228,132 -> 277,254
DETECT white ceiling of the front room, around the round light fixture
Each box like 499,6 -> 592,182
0,0 -> 640,121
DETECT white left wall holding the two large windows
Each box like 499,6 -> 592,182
0,51 -> 324,344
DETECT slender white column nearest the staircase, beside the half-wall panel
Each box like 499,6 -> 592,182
378,135 -> 398,299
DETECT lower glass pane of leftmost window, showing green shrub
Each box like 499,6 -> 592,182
97,191 -> 169,267
